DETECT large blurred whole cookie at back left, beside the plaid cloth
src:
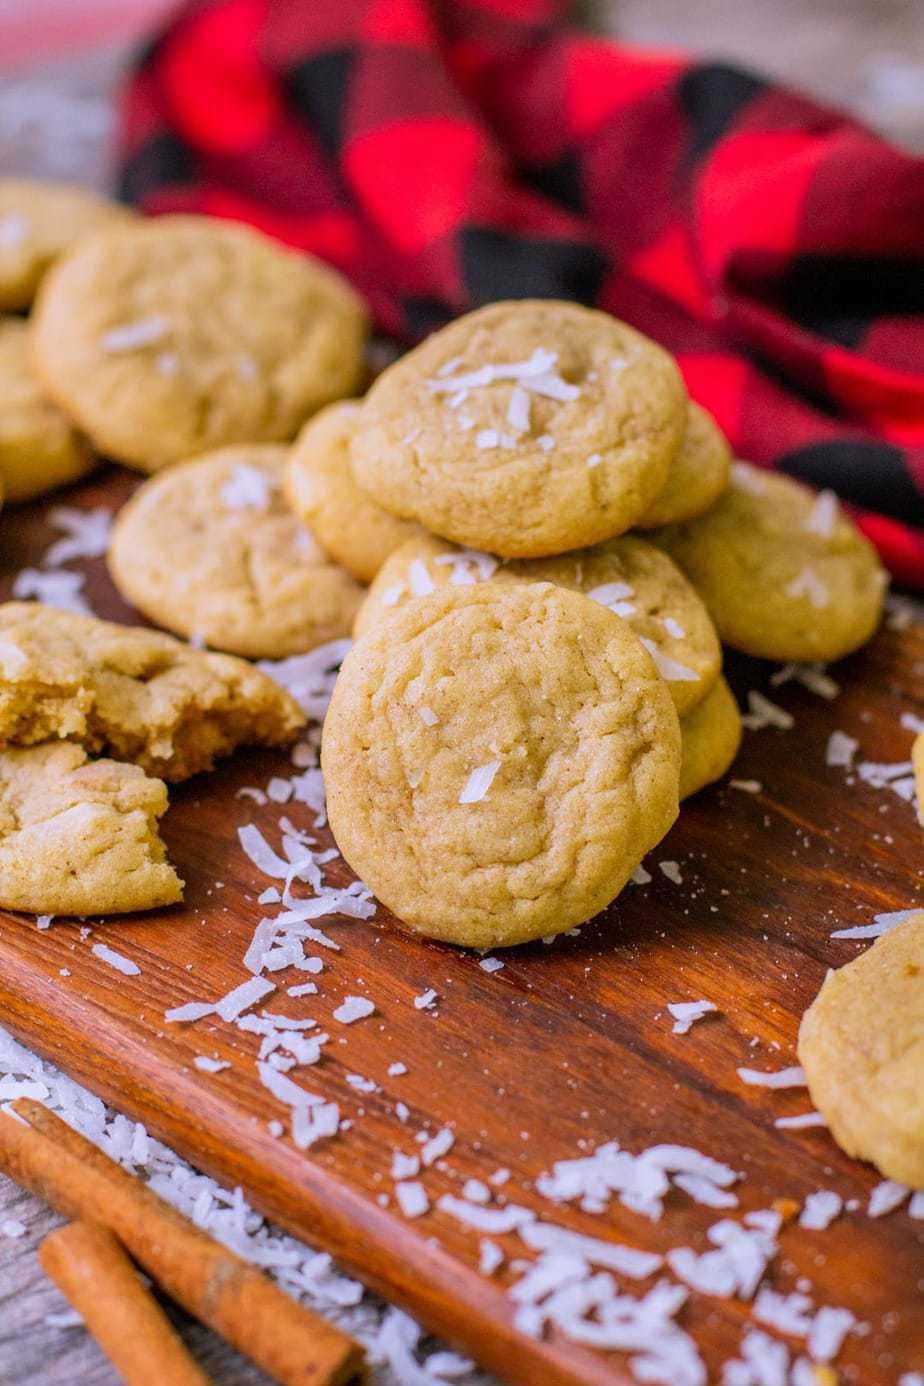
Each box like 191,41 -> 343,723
33,216 -> 366,471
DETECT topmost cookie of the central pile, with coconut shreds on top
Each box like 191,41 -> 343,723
352,299 -> 687,559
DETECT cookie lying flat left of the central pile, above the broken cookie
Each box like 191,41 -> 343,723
108,444 -> 363,660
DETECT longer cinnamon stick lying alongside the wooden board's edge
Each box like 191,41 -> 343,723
0,1098 -> 366,1386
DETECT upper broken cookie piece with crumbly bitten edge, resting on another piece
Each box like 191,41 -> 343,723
0,602 -> 305,780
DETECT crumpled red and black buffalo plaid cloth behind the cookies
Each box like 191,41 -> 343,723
121,0 -> 924,586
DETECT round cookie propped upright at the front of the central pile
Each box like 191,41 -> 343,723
321,584 -> 680,948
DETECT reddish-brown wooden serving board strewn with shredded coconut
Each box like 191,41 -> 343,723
0,471 -> 924,1386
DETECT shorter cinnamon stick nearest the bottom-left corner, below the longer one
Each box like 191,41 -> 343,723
39,1222 -> 209,1386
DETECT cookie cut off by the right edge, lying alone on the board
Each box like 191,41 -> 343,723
799,911 -> 924,1189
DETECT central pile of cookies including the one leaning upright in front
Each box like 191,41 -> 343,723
287,301 -> 885,947
